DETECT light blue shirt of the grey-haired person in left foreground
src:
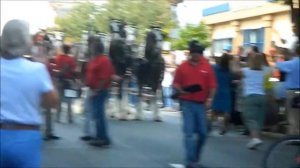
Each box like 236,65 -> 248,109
0,58 -> 54,125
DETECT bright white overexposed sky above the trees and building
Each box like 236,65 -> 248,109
0,0 -> 265,34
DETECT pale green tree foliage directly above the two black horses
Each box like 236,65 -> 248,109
96,0 -> 175,41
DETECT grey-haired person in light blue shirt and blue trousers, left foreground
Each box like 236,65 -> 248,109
0,20 -> 58,168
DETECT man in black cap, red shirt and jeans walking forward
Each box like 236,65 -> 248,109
173,40 -> 216,168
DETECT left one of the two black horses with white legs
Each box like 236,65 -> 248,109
109,20 -> 138,120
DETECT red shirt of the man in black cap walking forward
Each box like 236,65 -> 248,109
173,56 -> 217,103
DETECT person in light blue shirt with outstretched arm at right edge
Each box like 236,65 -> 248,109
276,43 -> 300,135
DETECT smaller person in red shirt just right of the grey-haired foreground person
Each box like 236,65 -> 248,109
54,44 -> 76,123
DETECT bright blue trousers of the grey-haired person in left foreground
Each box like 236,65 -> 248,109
0,129 -> 42,168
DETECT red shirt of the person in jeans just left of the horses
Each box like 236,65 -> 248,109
86,55 -> 115,89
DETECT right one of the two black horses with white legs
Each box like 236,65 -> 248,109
136,27 -> 165,122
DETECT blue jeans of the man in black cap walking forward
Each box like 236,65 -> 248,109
181,100 -> 207,165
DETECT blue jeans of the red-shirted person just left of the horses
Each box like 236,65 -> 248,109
91,90 -> 110,141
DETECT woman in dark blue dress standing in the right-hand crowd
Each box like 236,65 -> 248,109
212,53 -> 233,135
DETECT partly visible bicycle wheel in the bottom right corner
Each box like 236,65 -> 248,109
263,135 -> 300,168
